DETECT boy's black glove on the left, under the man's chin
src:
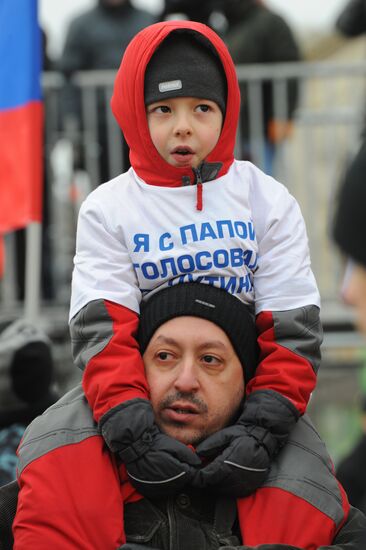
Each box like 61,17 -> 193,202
99,398 -> 201,498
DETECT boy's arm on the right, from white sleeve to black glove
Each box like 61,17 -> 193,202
193,178 -> 322,495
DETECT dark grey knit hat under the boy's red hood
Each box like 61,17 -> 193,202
145,29 -> 227,115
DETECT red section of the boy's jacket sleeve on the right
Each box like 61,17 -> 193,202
246,311 -> 316,414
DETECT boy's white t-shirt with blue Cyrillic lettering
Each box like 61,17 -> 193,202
70,161 -> 320,319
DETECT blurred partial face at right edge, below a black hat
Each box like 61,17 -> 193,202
342,264 -> 366,335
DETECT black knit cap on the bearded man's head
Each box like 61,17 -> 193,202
138,283 -> 258,383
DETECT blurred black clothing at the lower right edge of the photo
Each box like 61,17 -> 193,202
337,396 -> 366,513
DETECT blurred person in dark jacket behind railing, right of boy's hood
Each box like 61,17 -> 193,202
222,0 -> 302,174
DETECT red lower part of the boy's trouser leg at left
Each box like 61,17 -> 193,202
13,436 -> 125,550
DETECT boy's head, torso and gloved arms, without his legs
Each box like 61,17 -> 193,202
70,21 -> 321,497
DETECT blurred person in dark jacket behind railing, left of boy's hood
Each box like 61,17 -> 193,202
58,0 -> 156,184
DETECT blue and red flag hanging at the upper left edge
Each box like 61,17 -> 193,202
0,0 -> 43,235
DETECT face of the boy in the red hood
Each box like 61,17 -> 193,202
147,97 -> 223,168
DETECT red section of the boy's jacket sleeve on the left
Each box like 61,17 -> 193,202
79,301 -> 149,422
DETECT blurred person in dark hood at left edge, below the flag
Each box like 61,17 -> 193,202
0,319 -> 58,486
